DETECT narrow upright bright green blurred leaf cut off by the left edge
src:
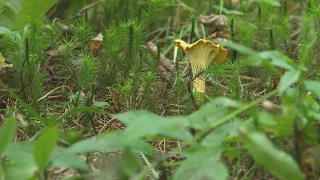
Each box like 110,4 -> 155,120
0,117 -> 17,158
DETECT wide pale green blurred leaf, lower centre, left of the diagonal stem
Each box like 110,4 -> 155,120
113,110 -> 193,144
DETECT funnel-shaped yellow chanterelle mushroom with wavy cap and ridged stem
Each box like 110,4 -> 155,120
174,39 -> 227,93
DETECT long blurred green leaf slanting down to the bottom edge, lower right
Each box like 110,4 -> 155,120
244,131 -> 304,180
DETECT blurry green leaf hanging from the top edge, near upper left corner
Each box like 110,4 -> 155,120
17,0 -> 56,28
